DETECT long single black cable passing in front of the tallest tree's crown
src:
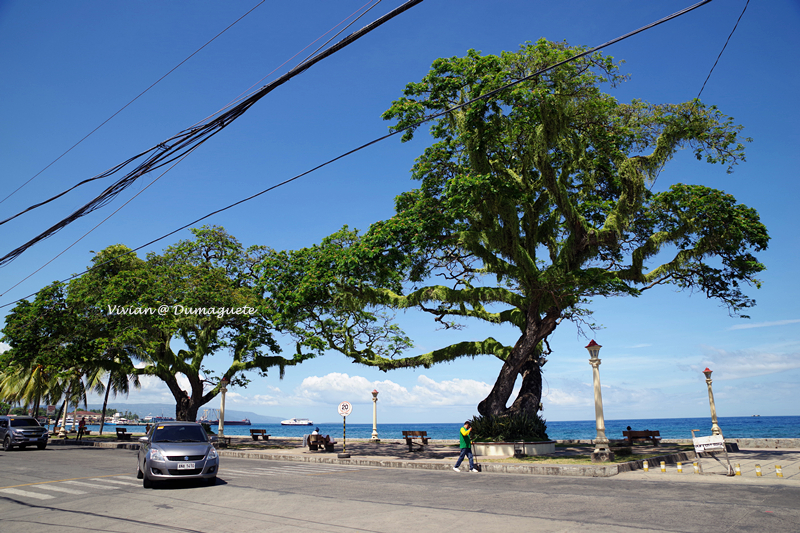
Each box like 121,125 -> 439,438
0,0 -> 711,309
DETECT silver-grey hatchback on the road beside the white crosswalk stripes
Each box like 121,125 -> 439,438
136,421 -> 219,488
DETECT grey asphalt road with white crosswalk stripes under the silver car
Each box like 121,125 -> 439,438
0,446 -> 800,533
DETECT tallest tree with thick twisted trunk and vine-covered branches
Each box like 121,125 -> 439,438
276,40 -> 768,415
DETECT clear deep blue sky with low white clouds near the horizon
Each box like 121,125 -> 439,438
0,0 -> 800,429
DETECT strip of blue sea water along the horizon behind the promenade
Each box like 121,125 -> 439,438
76,416 -> 800,440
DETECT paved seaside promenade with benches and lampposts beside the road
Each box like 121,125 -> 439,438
52,436 -> 800,487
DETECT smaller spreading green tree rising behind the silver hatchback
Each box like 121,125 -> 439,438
70,226 -> 313,420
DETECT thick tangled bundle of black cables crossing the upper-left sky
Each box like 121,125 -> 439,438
0,0 -> 422,266
